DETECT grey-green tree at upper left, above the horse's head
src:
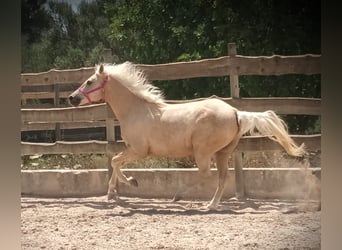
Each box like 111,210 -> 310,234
22,0 -> 110,72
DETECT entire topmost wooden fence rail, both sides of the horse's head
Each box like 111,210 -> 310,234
21,54 -> 321,86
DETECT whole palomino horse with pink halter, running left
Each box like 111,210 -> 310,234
69,62 -> 305,209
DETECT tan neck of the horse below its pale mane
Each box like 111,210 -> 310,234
105,79 -> 157,123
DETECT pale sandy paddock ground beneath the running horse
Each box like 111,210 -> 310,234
21,196 -> 321,250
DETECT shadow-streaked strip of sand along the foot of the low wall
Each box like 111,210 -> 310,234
21,196 -> 320,217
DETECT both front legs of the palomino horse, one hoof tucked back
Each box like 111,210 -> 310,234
107,150 -> 141,201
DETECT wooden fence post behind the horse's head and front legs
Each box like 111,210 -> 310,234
103,49 -> 115,180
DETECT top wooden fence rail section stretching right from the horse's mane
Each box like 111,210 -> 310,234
138,55 -> 320,80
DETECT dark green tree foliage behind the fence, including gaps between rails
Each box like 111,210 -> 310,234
22,0 -> 321,133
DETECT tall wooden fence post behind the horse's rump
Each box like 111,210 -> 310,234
228,43 -> 245,198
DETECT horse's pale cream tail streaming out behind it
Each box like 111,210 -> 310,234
237,110 -> 305,156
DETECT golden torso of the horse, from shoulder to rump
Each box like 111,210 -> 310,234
149,98 -> 238,156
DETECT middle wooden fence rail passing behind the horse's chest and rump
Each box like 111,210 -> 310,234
21,97 -> 321,124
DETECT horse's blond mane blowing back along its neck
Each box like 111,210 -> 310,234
104,62 -> 164,103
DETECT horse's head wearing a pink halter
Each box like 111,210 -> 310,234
68,64 -> 108,107
